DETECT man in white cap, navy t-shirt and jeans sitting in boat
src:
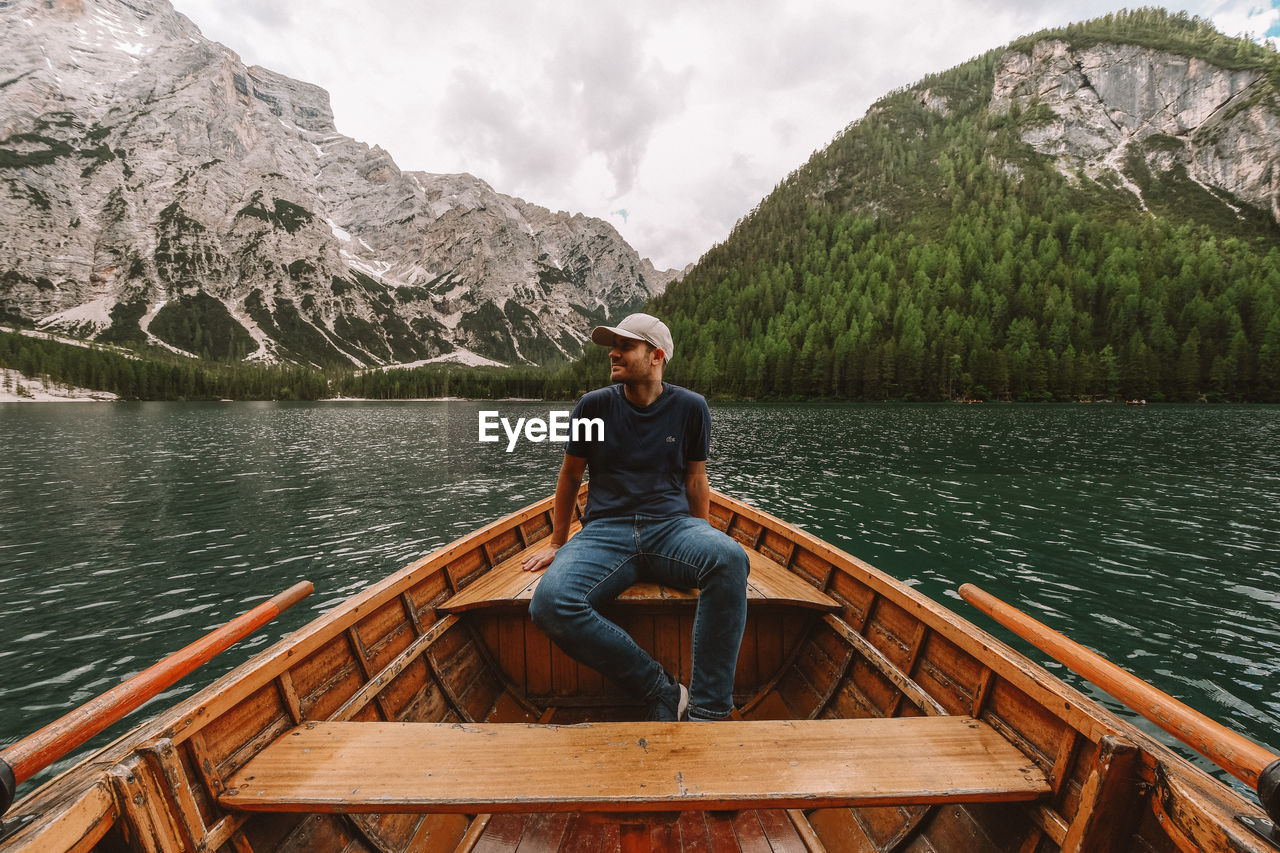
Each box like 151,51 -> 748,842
524,314 -> 749,720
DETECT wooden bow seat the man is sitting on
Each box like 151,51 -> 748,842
440,525 -> 840,613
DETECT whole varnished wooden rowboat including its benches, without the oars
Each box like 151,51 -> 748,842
0,491 -> 1280,853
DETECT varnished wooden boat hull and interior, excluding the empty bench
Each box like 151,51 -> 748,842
0,484 -> 1276,853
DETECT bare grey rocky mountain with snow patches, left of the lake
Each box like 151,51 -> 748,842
0,0 -> 676,365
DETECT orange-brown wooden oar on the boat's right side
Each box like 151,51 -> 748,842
960,584 -> 1280,826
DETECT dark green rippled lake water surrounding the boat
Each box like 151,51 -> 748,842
0,402 -> 1280,799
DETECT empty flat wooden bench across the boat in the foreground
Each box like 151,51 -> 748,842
218,716 -> 1050,815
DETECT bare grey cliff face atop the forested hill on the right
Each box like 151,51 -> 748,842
989,38 -> 1280,222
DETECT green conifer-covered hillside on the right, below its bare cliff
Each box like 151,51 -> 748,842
653,10 -> 1280,402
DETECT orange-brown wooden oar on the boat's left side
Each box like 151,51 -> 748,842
0,580 -> 315,815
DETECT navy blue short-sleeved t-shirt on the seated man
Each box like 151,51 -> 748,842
564,383 -> 712,523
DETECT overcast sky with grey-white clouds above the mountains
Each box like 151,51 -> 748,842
174,0 -> 1280,268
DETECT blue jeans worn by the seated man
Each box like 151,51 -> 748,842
529,515 -> 750,720
